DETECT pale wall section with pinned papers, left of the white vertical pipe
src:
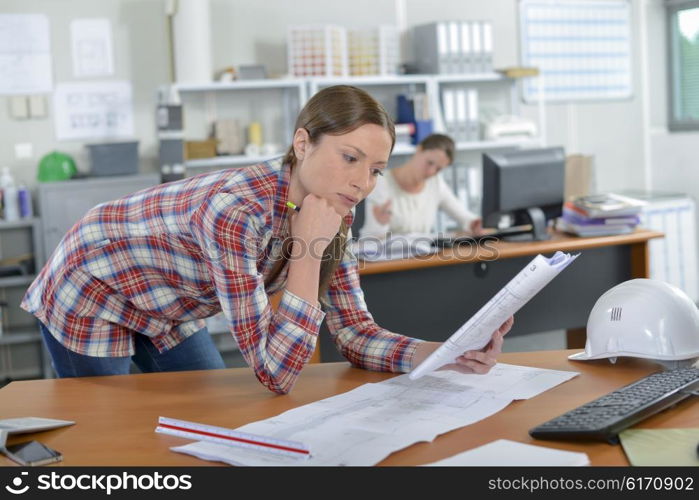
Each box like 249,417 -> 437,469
0,0 -> 168,185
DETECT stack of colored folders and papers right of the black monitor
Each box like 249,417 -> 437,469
557,193 -> 646,236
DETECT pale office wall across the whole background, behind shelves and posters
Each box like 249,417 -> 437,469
0,0 -> 656,195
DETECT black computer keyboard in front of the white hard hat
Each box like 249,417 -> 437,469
529,368 -> 699,443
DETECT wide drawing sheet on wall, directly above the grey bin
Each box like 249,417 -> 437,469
53,81 -> 133,141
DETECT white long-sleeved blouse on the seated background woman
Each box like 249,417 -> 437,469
359,170 -> 478,238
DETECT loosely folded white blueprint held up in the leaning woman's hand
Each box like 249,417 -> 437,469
409,252 -> 579,380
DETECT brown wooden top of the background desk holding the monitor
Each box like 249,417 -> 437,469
360,229 -> 664,274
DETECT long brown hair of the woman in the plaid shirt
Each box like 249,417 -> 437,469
269,85 -> 396,301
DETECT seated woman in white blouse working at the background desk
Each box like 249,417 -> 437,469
360,134 -> 481,238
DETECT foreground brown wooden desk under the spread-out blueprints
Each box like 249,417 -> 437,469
0,351 -> 699,466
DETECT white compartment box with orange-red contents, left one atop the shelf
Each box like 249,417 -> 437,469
287,24 -> 349,77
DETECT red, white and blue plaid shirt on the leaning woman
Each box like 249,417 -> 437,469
22,159 -> 419,393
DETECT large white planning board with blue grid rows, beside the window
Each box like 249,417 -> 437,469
520,0 -> 633,103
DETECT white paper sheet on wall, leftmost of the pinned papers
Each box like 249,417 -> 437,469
0,14 -> 53,95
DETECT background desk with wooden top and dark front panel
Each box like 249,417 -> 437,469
320,230 -> 663,361
